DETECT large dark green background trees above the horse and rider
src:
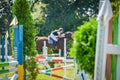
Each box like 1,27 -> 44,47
33,0 -> 99,35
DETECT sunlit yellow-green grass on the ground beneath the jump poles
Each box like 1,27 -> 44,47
0,63 -> 79,80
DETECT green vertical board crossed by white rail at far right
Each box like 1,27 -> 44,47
112,18 -> 118,80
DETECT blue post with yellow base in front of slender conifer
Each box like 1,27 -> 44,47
14,25 -> 24,80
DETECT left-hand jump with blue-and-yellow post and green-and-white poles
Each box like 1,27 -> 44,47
0,25 -> 24,80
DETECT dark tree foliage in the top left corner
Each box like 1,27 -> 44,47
0,0 -> 12,35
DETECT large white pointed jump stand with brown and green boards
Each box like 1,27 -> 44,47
94,0 -> 120,80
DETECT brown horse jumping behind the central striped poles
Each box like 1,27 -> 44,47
35,32 -> 72,50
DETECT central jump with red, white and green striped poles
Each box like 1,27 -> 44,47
35,39 -> 77,80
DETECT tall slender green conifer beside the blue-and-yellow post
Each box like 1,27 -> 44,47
13,0 -> 37,80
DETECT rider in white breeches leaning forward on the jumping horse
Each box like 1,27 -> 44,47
50,28 -> 64,47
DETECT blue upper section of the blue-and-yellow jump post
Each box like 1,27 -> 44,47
14,25 -> 23,64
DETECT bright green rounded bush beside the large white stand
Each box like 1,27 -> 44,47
70,19 -> 97,76
